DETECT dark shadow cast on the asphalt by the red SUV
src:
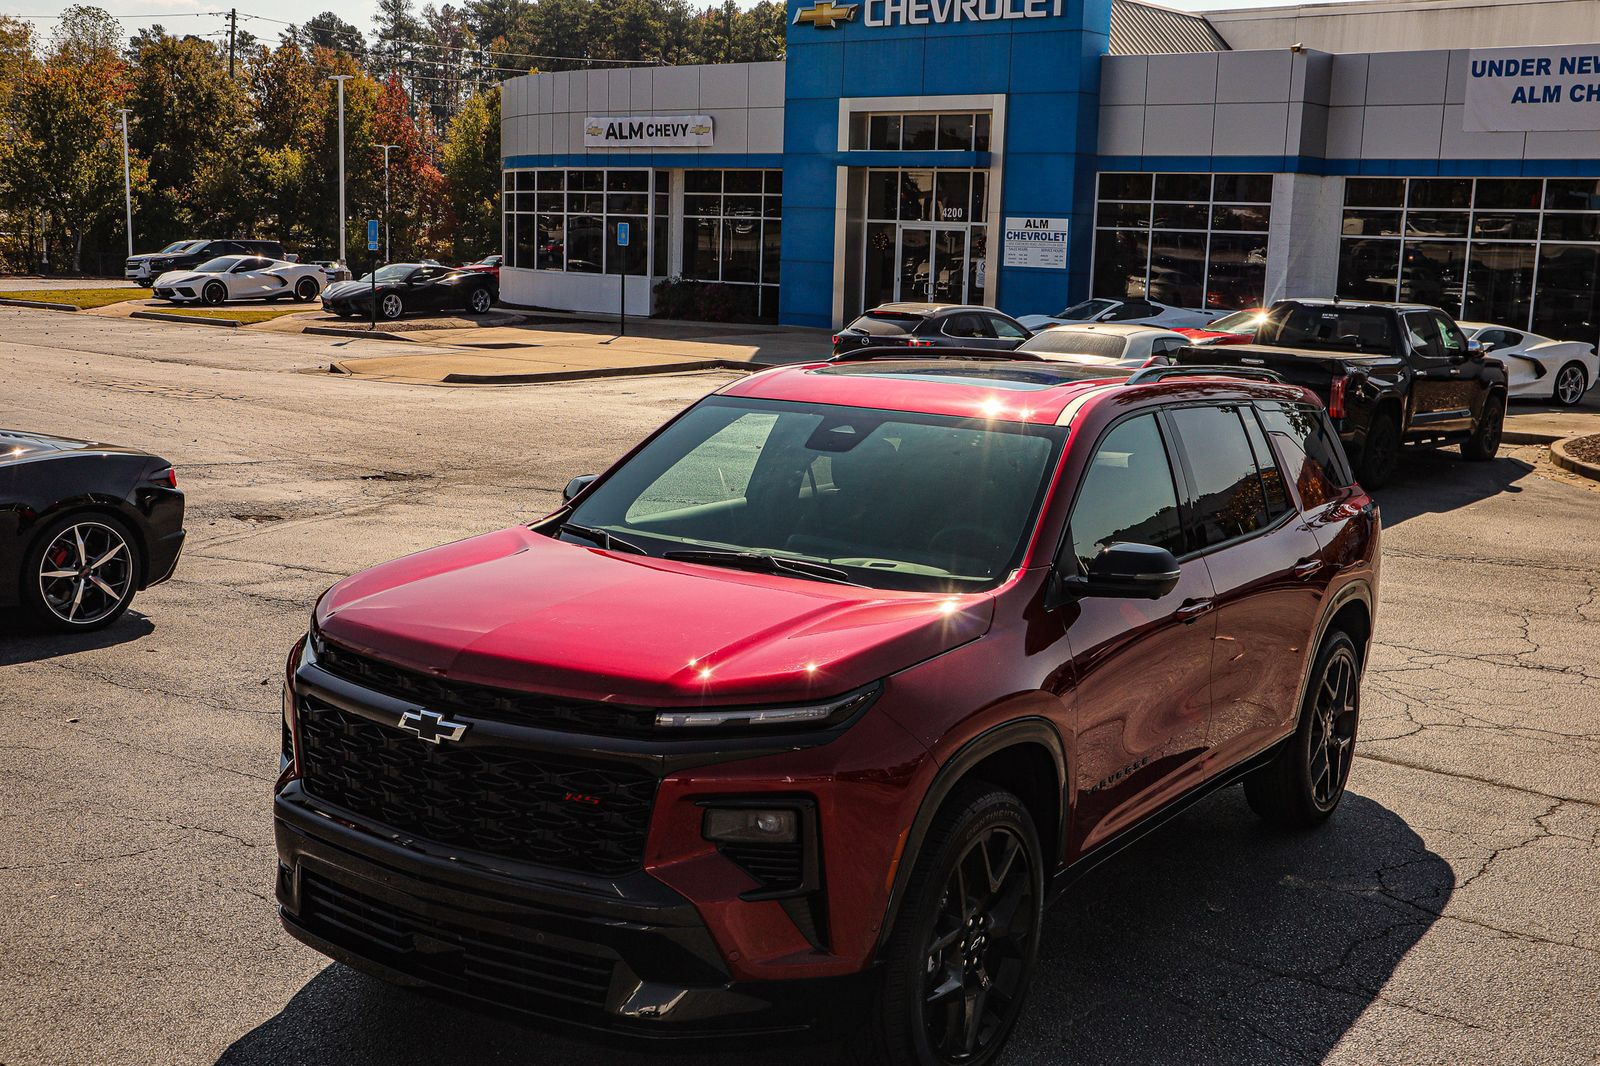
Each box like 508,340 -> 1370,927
218,781 -> 1454,1066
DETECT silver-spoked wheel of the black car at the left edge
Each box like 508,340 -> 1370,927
19,511 -> 144,632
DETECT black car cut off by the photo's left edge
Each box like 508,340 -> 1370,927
0,429 -> 184,631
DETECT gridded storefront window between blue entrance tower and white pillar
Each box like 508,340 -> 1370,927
1091,173 -> 1272,309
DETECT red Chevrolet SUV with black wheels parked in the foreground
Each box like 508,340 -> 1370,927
274,359 -> 1378,1063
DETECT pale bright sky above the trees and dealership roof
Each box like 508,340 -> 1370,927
0,0 -> 1324,52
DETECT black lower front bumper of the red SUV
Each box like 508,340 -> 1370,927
274,793 -> 867,1039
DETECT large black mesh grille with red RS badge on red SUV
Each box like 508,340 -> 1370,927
299,699 -> 658,874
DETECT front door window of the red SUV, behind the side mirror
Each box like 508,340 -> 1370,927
1070,415 -> 1184,570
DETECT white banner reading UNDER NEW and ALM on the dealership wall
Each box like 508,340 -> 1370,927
1461,45 -> 1600,133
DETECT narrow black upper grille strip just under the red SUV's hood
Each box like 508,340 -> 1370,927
317,633 -> 656,736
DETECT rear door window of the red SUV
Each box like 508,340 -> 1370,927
1171,407 -> 1267,549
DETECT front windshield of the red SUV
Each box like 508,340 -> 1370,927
565,397 -> 1064,592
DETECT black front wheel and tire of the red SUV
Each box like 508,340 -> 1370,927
853,783 -> 1045,1066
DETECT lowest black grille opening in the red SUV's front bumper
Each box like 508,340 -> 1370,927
299,869 -> 614,1015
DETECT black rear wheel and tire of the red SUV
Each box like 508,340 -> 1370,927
1245,629 -> 1362,829
